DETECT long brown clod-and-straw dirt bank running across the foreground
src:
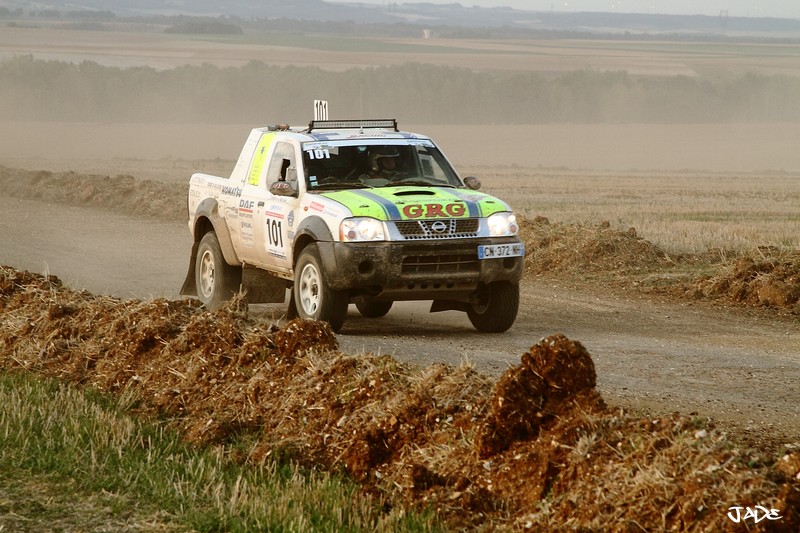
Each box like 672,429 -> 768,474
0,267 -> 800,531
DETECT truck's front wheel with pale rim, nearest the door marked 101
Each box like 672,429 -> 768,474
292,244 -> 348,333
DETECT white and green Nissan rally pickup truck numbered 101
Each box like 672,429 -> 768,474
181,119 -> 525,333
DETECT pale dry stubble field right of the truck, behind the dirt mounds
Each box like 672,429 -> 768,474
470,168 -> 800,254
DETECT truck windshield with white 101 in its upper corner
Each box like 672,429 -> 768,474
303,141 -> 463,190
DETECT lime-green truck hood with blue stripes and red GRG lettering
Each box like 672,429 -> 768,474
321,186 -> 510,220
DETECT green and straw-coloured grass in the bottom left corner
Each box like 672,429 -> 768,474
0,374 -> 436,531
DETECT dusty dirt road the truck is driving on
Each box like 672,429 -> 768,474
0,196 -> 800,445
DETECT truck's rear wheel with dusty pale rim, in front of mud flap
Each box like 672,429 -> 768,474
194,231 -> 242,311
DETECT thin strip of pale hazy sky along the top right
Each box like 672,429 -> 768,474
342,0 -> 800,19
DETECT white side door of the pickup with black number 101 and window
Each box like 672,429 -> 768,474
253,141 -> 299,273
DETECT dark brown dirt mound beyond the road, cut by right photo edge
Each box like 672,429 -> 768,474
682,248 -> 800,315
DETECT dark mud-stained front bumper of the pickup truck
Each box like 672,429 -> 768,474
317,237 -> 524,300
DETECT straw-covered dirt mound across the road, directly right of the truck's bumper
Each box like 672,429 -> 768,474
520,217 -> 670,275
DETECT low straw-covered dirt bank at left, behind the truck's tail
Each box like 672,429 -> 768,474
0,166 -> 188,221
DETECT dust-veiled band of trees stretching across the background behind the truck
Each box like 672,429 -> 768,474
0,55 -> 800,124
